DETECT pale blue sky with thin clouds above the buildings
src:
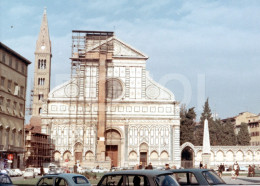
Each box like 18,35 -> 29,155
0,0 -> 260,119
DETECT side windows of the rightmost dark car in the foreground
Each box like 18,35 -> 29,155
173,172 -> 199,185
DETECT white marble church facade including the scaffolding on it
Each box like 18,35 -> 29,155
41,31 -> 181,167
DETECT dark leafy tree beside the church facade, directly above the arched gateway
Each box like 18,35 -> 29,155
180,107 -> 196,144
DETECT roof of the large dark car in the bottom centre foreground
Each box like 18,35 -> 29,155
104,170 -> 172,176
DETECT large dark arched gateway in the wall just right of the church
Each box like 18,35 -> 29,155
181,146 -> 194,168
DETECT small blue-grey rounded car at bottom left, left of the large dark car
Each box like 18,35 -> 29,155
36,173 -> 91,186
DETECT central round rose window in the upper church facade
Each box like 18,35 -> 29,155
106,79 -> 123,99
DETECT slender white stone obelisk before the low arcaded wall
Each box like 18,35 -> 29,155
202,118 -> 211,168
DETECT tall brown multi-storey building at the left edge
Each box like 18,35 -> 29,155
0,42 -> 31,168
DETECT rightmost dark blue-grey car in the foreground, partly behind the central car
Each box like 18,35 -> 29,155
169,169 -> 226,185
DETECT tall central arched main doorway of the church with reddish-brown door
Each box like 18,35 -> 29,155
106,129 -> 121,167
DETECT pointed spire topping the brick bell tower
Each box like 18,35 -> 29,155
35,7 -> 51,54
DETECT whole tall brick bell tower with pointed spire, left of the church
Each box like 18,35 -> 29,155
32,8 -> 52,117
